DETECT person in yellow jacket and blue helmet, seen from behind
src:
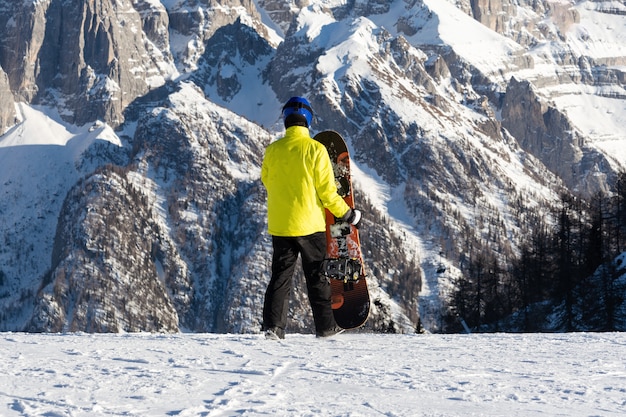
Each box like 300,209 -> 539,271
261,97 -> 361,339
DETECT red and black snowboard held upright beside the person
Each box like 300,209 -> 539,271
314,130 -> 370,329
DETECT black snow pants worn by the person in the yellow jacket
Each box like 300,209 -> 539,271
263,232 -> 335,333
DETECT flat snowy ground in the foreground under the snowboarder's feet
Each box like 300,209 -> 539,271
0,333 -> 626,417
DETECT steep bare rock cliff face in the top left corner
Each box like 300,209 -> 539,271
0,0 -> 175,126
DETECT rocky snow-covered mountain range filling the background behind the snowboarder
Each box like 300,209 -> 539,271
0,0 -> 626,332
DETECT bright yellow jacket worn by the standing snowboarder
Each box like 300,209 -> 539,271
261,126 -> 350,236
